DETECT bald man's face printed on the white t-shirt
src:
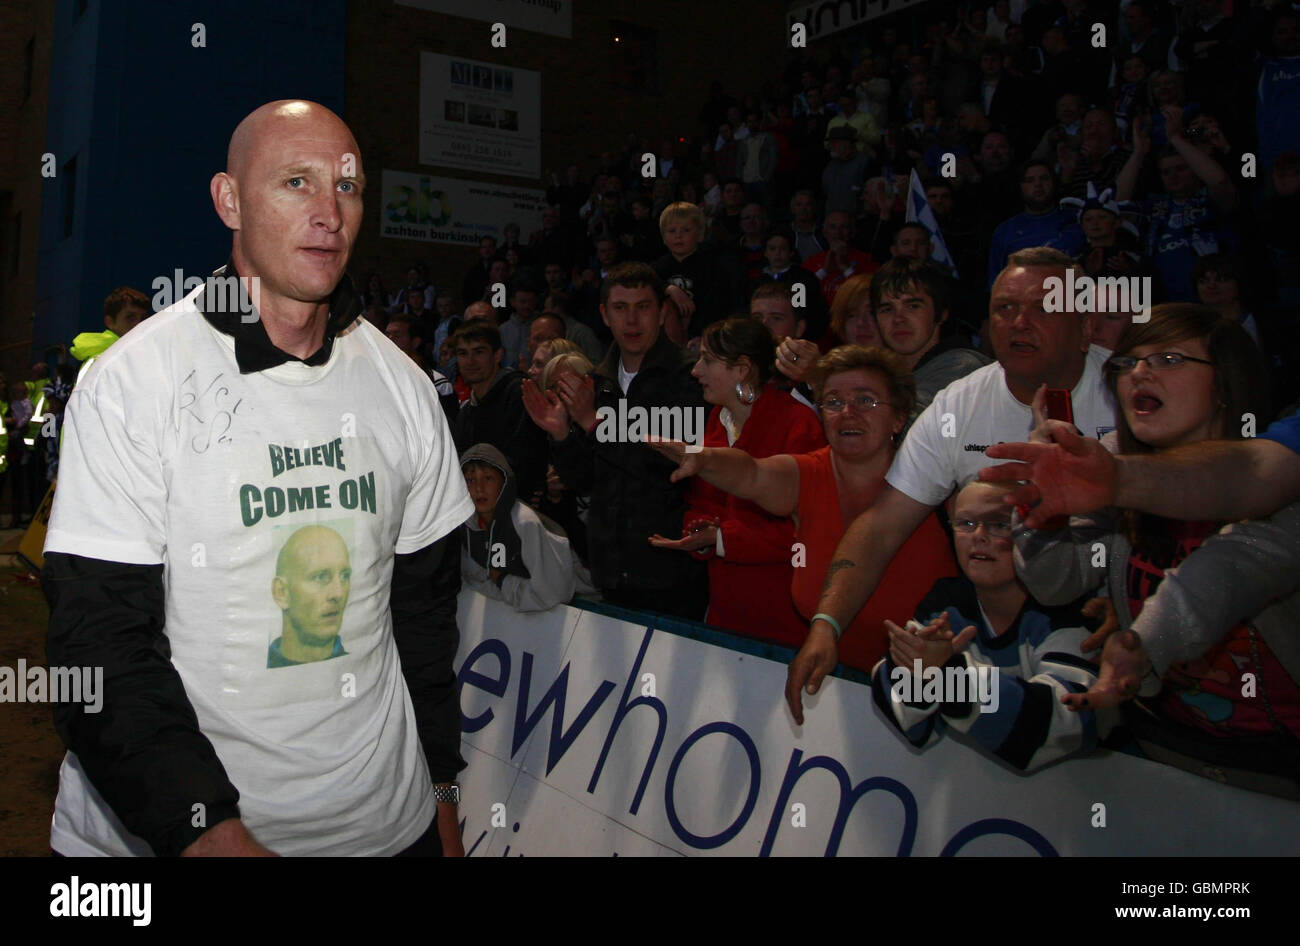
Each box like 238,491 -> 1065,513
267,525 -> 352,667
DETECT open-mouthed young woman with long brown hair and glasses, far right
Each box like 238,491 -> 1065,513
1015,303 -> 1300,797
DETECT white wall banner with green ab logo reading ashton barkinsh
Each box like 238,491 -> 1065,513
380,169 -> 546,246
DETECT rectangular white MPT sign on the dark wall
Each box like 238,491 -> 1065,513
420,52 -> 542,178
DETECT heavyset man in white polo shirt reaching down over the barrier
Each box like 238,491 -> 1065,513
785,247 -> 1115,724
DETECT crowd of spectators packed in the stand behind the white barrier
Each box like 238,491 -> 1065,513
10,0 -> 1300,795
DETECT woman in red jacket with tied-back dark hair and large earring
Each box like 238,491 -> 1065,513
650,317 -> 826,646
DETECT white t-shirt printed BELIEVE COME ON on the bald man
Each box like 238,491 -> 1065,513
46,283 -> 473,855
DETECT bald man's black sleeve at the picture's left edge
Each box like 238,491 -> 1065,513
40,552 -> 239,856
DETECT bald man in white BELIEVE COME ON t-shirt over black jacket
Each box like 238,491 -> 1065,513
43,101 -> 473,855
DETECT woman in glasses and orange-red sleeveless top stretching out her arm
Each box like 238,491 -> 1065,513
657,344 -> 957,672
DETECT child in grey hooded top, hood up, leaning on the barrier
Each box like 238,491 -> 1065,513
460,443 -> 595,611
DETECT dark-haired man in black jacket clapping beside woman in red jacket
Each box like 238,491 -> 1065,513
524,262 -> 709,620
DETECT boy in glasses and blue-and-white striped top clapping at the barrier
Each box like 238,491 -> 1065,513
871,481 -> 1118,772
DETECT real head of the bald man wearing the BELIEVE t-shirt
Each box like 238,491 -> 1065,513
211,100 -> 365,320
